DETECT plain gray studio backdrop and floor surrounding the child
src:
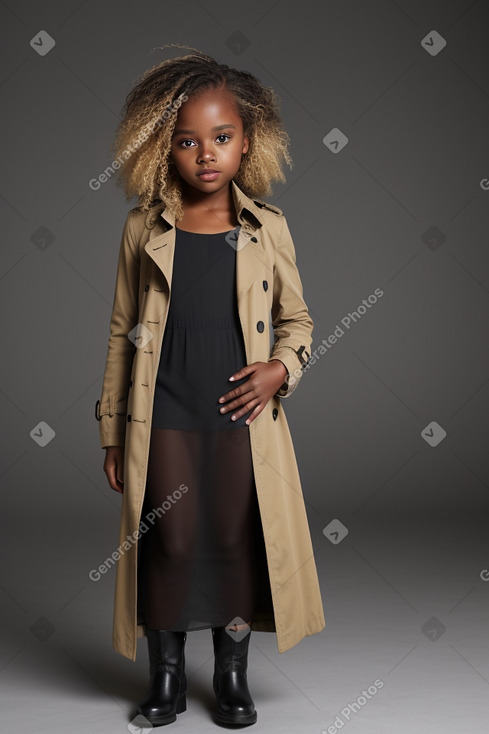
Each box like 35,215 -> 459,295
0,0 -> 489,734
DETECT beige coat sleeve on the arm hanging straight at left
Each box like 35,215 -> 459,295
95,210 -> 140,448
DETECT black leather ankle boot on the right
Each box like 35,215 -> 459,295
212,627 -> 257,725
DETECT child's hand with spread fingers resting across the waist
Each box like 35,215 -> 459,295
219,359 -> 288,425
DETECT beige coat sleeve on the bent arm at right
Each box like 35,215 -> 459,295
268,215 -> 314,398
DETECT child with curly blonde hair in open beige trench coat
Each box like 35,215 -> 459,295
96,47 -> 325,726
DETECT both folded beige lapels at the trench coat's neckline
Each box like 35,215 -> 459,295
144,181 -> 264,308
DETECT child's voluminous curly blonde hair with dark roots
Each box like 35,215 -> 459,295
112,44 -> 293,220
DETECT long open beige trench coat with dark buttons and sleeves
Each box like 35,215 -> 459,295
95,181 -> 325,661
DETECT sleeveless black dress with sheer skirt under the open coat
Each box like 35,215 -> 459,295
138,228 -> 273,630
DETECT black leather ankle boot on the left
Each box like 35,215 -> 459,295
137,629 -> 187,726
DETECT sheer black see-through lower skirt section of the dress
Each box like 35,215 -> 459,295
139,427 -> 271,630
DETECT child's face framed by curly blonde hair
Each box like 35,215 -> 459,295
171,89 -> 249,201
